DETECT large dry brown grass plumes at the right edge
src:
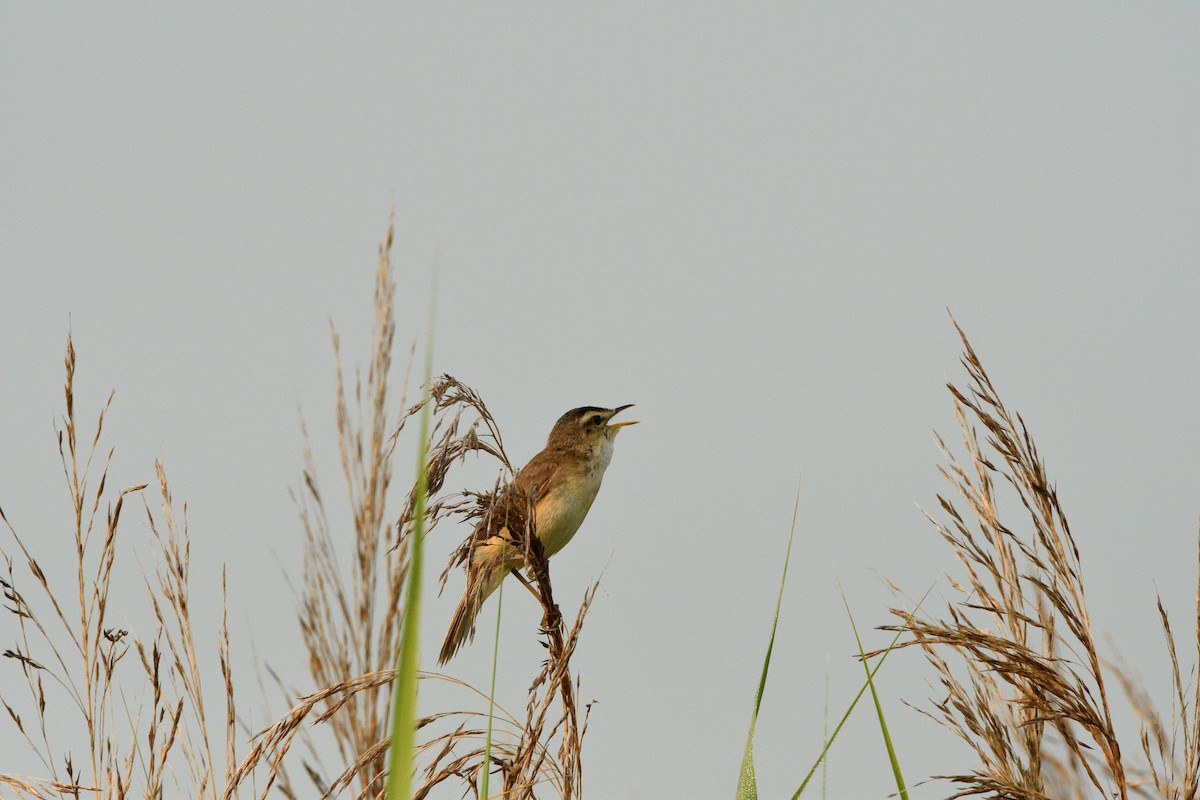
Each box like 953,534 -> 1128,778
894,318 -> 1200,800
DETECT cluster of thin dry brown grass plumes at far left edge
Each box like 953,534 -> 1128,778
0,337 -> 235,799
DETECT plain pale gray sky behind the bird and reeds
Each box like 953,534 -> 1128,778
0,2 -> 1200,800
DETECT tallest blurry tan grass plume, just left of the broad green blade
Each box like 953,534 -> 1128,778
273,224 -> 410,796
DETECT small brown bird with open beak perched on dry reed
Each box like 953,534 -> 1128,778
438,404 -> 637,664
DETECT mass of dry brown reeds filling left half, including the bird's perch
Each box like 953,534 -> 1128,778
0,230 -> 595,800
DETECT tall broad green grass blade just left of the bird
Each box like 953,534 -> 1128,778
385,278 -> 436,800
